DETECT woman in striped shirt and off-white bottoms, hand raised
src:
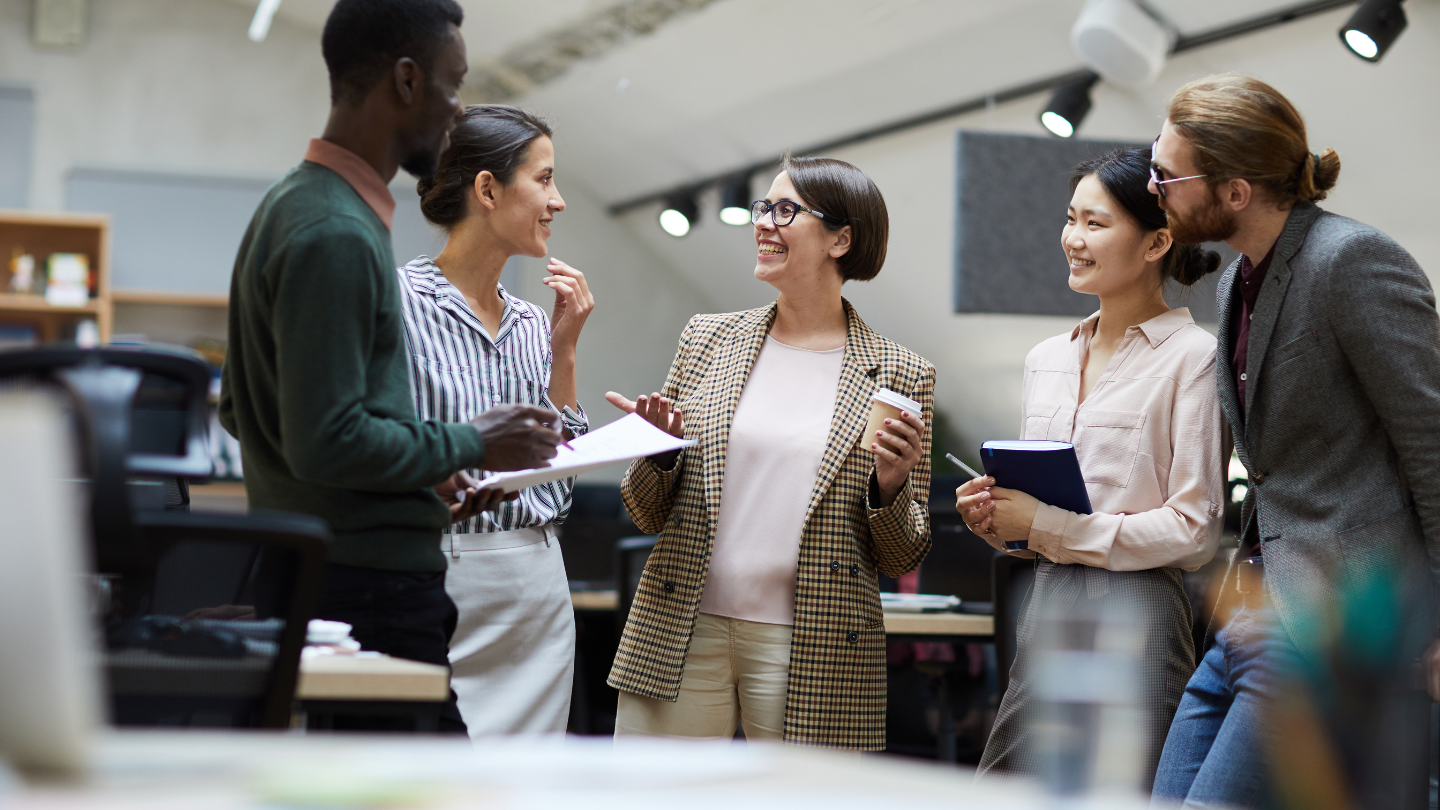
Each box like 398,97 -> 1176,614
397,105 -> 595,736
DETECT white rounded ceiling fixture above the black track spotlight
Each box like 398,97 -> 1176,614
1070,0 -> 1175,89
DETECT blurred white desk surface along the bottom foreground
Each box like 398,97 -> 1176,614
6,731 -> 1148,810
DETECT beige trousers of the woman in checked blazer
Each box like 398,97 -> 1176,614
615,613 -> 793,739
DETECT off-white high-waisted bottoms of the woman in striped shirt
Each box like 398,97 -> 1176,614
441,526 -> 575,739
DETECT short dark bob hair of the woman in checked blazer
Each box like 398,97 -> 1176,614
780,153 -> 890,281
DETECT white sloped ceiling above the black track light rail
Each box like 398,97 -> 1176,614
213,0 -> 1319,203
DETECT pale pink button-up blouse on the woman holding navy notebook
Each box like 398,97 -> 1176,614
1021,308 -> 1225,571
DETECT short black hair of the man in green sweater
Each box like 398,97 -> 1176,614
320,0 -> 465,104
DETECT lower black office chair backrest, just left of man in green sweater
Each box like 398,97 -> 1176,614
105,512 -> 330,728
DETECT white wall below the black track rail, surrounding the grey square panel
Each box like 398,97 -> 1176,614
604,0 -> 1440,455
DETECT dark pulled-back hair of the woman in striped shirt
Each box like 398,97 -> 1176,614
415,104 -> 553,231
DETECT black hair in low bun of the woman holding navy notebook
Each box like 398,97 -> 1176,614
1070,147 -> 1220,287
